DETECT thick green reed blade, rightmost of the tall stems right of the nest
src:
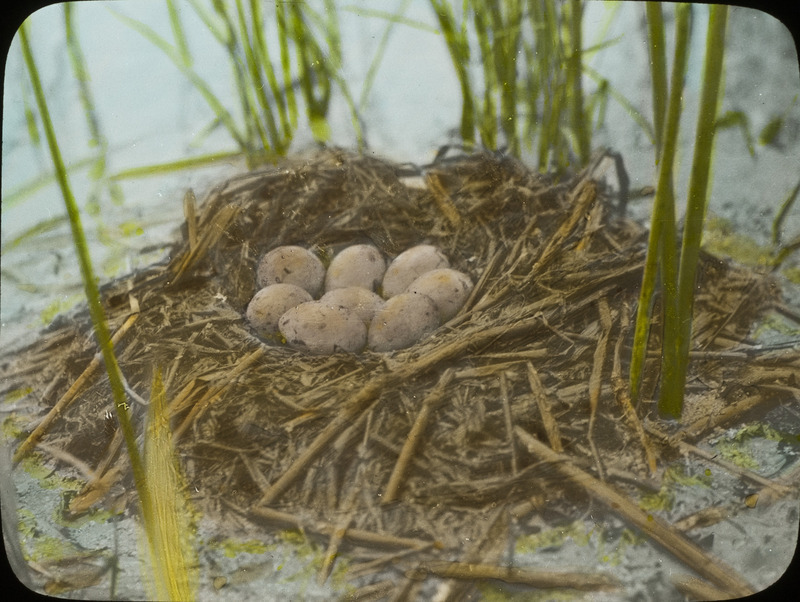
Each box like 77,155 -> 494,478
659,4 -> 728,417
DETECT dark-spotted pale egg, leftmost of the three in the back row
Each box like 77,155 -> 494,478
256,245 -> 325,297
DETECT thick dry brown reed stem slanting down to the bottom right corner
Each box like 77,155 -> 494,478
516,427 -> 755,597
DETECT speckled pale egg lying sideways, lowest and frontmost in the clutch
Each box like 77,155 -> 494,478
278,301 -> 367,355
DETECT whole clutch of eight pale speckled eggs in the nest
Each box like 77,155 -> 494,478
245,244 -> 473,354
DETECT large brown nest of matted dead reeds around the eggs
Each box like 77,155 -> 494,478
0,151 -> 798,599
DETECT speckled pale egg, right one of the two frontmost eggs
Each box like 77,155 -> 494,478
367,293 -> 439,351
